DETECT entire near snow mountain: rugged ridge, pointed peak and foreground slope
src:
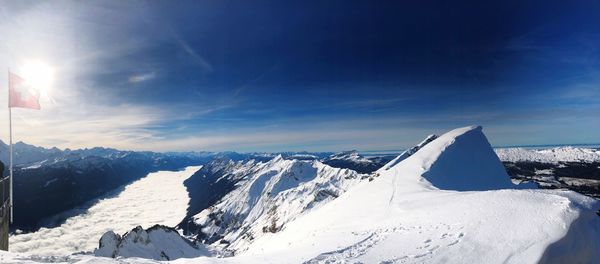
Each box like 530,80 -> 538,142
1,126 -> 600,263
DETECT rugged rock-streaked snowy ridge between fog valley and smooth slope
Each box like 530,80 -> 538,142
193,156 -> 367,255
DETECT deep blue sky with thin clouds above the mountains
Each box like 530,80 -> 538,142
0,0 -> 600,151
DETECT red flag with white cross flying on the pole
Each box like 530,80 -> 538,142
8,72 -> 41,110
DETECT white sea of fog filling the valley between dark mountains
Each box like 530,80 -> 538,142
10,166 -> 200,255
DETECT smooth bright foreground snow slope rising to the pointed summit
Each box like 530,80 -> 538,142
0,127 -> 600,263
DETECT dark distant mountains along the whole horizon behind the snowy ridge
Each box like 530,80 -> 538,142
0,135 -> 600,234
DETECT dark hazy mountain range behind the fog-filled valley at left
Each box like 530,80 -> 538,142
0,142 -> 211,231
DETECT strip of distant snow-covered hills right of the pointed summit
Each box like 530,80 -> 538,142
495,147 -> 600,164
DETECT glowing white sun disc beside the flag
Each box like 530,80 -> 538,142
20,61 -> 54,96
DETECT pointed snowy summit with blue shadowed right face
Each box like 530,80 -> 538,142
390,126 -> 515,191
